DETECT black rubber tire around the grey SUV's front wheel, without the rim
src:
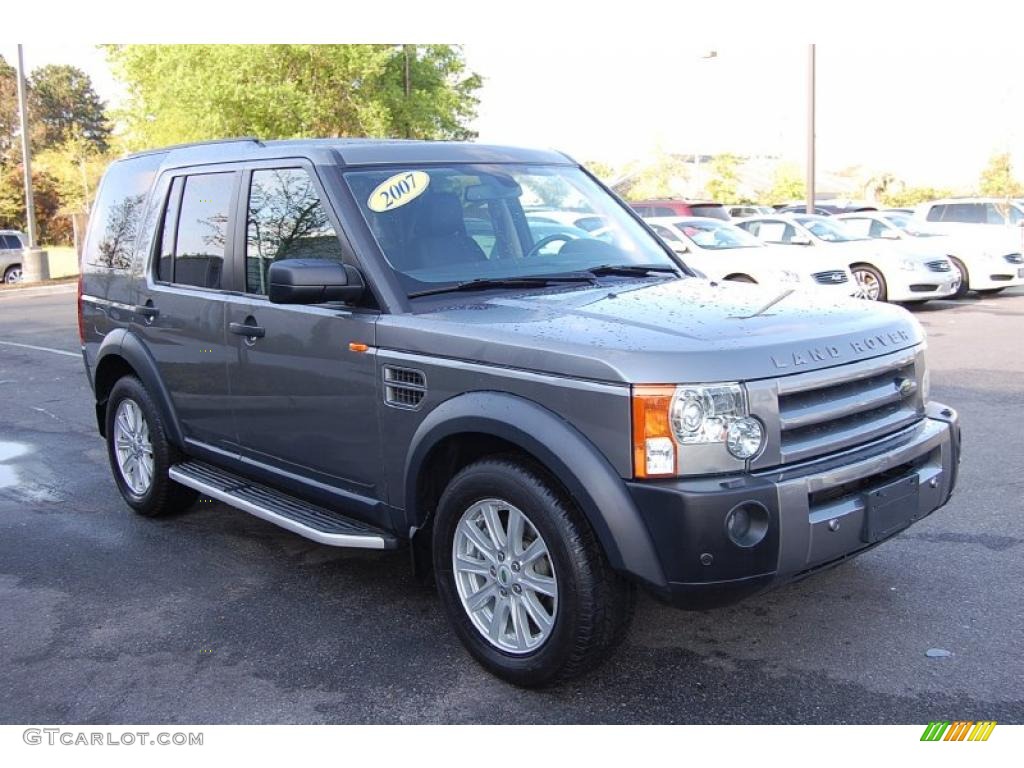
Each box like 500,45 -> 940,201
432,457 -> 636,687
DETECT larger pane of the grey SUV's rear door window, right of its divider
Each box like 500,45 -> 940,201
174,173 -> 234,288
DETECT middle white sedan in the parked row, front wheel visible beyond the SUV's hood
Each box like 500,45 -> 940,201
738,214 -> 959,301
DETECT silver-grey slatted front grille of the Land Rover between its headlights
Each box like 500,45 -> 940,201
778,351 -> 924,464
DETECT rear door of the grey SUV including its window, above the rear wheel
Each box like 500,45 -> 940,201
134,168 -> 240,451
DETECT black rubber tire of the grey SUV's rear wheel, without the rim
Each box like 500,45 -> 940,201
105,376 -> 199,517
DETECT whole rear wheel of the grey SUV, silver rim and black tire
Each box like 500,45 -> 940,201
106,376 -> 198,517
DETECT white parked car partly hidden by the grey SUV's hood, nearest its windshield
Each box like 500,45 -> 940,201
646,216 -> 857,296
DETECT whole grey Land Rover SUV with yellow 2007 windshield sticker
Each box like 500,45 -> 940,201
80,139 -> 959,685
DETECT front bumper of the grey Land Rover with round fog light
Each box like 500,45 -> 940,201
628,403 -> 961,608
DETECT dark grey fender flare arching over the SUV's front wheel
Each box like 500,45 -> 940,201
399,392 -> 667,588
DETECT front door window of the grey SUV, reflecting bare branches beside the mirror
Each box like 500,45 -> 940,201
246,168 -> 342,295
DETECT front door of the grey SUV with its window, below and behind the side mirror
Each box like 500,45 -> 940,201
227,163 -> 381,499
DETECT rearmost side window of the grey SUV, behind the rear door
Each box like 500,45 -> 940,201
83,155 -> 164,269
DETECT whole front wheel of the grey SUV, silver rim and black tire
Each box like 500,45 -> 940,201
433,459 -> 635,687
